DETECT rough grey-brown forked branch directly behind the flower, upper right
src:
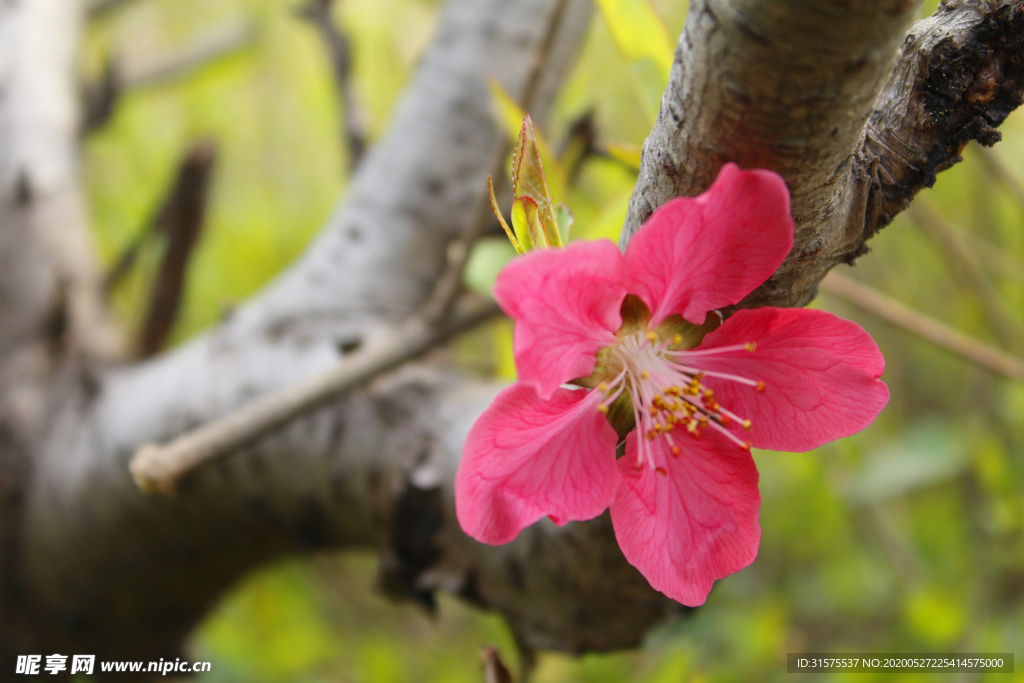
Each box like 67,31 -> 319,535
623,0 -> 1024,307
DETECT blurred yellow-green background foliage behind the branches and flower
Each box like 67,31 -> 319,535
81,0 -> 1024,683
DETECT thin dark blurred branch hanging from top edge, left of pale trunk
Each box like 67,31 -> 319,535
296,0 -> 367,171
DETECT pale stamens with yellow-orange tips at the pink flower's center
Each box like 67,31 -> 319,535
596,330 -> 765,474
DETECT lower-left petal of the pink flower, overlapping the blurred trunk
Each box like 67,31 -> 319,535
455,382 -> 618,545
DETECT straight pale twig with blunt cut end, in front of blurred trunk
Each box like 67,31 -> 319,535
129,299 -> 501,494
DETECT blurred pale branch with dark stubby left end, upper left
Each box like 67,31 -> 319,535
82,20 -> 256,135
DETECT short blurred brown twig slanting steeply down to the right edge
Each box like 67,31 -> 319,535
907,198 -> 1024,348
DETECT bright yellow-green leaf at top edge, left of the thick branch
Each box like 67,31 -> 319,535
597,0 -> 676,123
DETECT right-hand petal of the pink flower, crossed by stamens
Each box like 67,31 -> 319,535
687,308 -> 889,451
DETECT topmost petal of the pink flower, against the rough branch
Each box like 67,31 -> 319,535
626,164 -> 793,326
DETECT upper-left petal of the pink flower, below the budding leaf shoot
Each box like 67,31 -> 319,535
495,240 -> 626,398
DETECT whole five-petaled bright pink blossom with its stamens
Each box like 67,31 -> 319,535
455,164 -> 889,606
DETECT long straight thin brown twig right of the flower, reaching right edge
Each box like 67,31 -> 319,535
821,271 -> 1024,382
